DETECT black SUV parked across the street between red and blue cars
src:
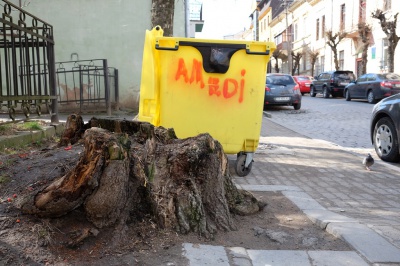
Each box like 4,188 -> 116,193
310,70 -> 356,98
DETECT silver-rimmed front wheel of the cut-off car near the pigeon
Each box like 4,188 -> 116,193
373,117 -> 400,162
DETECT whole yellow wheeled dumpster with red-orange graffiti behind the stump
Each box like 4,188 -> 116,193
138,26 -> 275,176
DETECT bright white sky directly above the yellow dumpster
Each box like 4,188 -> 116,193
196,0 -> 254,39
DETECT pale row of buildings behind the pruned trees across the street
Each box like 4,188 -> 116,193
256,0 -> 400,76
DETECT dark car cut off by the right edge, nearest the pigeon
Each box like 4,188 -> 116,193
370,94 -> 400,162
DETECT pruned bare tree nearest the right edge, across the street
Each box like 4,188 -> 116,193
372,9 -> 400,72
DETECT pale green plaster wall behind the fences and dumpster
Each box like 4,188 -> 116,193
19,0 -> 185,109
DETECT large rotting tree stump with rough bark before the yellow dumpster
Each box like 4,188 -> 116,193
21,118 -> 263,240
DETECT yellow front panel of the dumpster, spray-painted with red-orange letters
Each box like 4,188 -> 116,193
160,46 -> 268,154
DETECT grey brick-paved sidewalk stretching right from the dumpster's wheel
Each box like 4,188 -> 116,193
234,117 -> 400,248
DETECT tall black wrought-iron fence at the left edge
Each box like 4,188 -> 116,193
0,0 -> 58,122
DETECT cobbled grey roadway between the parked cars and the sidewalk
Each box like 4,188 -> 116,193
261,94 -> 375,154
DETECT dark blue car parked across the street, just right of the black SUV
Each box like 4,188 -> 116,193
344,73 -> 400,103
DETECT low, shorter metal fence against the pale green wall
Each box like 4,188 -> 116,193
56,59 -> 119,115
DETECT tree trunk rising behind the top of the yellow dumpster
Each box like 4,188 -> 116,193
151,0 -> 175,36
